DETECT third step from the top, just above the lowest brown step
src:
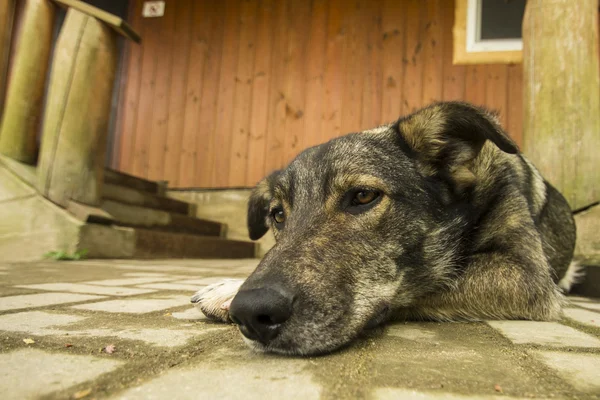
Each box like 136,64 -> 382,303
100,200 -> 227,236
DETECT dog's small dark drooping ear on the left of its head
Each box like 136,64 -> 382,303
248,171 -> 280,240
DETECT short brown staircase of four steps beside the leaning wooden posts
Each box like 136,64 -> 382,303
88,169 -> 256,259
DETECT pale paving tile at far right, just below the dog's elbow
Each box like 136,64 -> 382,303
488,321 -> 600,347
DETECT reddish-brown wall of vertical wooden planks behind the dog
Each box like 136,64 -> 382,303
113,0 -> 522,187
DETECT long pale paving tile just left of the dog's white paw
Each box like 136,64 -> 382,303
72,296 -> 190,314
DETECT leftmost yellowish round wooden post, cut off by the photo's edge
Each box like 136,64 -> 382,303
0,0 -> 55,164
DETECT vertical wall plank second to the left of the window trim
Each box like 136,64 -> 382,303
421,0 -> 447,106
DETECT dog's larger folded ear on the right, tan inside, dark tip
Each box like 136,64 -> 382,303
398,102 -> 519,192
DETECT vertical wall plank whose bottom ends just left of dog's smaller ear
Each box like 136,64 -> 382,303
226,0 -> 258,187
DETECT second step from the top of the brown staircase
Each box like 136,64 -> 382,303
102,183 -> 194,215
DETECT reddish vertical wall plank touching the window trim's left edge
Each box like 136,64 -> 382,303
442,1 -> 466,100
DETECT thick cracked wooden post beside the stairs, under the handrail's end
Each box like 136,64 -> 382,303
38,8 -> 118,207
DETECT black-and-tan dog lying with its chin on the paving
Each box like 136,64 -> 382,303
192,102 -> 579,355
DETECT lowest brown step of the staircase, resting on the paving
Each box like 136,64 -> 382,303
133,228 -> 256,259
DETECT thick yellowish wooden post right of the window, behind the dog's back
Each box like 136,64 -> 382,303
523,0 -> 600,209
